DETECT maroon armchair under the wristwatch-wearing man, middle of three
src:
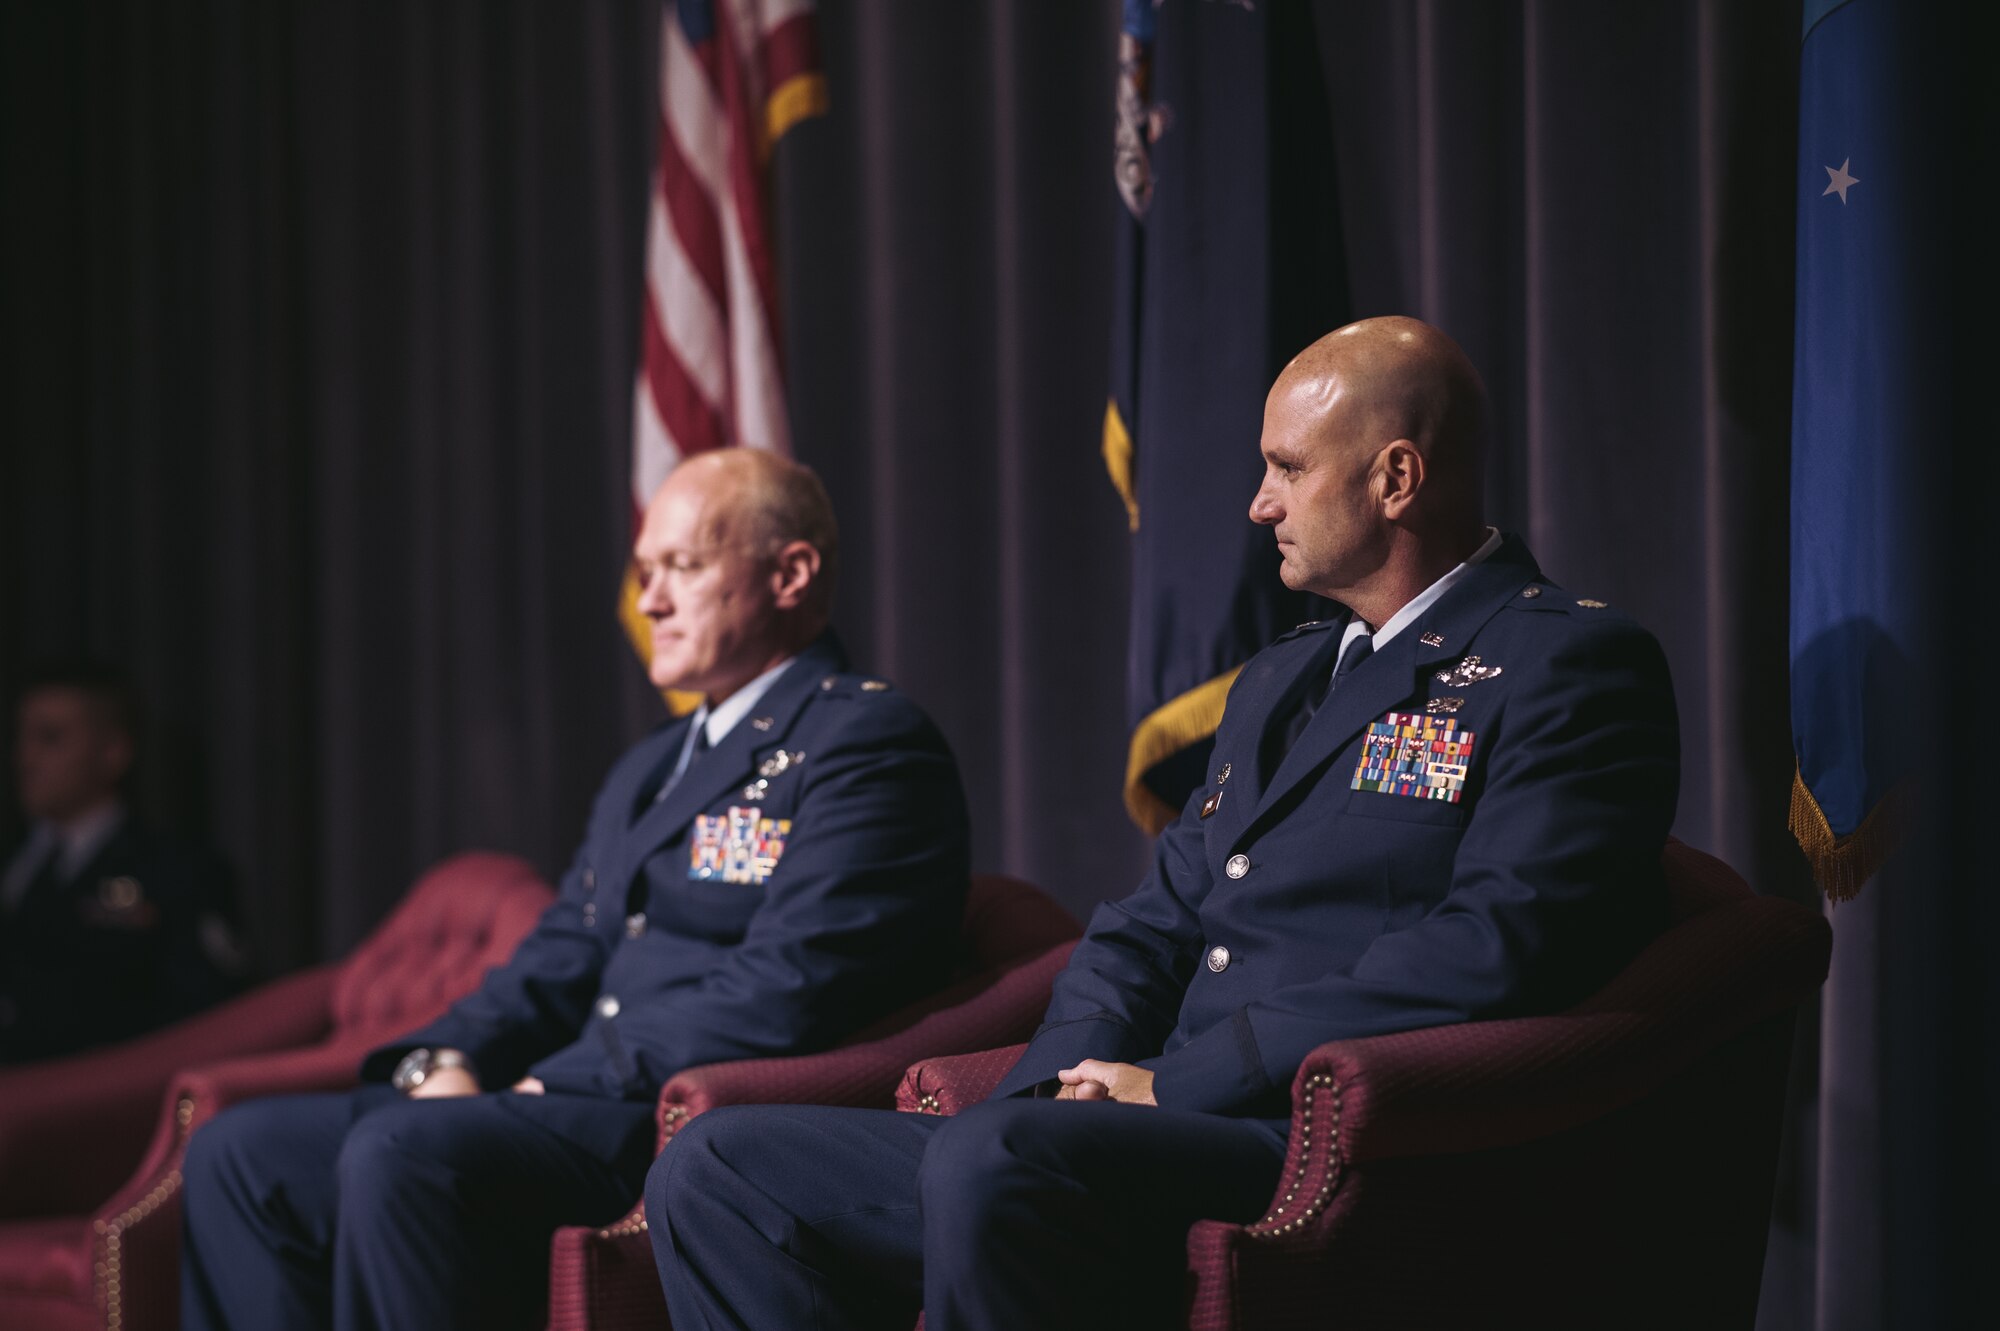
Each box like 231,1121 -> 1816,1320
548,875 -> 1080,1331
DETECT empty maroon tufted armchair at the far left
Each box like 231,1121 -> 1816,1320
0,853 -> 552,1331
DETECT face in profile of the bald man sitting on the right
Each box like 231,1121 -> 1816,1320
1250,376 -> 1384,598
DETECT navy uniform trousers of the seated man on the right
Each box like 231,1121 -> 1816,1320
646,1099 -> 1290,1331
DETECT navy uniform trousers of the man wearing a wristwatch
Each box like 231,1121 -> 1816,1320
180,1085 -> 652,1331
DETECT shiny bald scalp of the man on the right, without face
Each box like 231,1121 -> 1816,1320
1272,314 -> 1486,507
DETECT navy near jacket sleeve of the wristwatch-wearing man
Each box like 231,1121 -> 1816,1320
534,695 -> 970,1095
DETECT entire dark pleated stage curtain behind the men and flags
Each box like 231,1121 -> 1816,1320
0,0 -> 1968,1327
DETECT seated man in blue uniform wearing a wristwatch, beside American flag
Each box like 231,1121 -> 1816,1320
182,450 -> 968,1329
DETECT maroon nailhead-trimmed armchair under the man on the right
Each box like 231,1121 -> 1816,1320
896,841 -> 1832,1331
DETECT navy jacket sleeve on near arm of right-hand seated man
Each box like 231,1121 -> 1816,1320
1142,620 -> 1680,1113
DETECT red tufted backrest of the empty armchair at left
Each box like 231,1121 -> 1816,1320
330,853 -> 548,1039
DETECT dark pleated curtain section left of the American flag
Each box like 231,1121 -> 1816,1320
0,0 -> 660,969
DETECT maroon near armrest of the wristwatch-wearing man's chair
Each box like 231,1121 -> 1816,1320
660,941 -> 1076,1149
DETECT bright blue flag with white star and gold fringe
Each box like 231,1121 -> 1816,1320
1792,0 -> 1942,899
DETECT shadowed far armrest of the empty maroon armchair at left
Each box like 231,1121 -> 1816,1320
0,965 -> 338,1217
